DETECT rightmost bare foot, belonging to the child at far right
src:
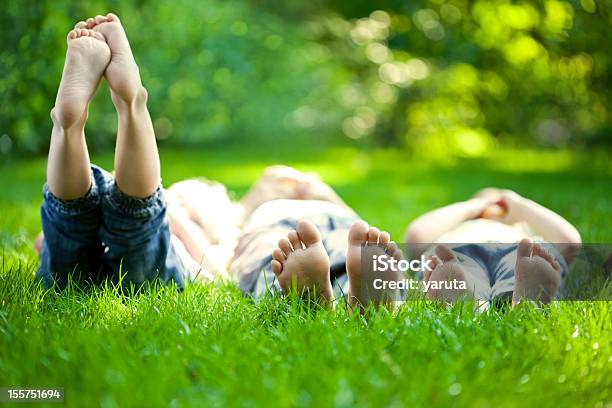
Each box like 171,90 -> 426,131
512,238 -> 561,305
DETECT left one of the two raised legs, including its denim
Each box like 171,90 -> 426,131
37,29 -> 110,286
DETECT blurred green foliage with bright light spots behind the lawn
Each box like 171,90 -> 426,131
0,0 -> 612,156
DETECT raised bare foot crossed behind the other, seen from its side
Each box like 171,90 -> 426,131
75,13 -> 143,103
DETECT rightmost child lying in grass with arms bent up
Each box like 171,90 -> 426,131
406,188 -> 581,304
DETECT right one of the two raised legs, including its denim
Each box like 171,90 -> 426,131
79,14 -> 186,285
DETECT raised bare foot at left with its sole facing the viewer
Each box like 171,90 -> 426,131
52,28 -> 111,129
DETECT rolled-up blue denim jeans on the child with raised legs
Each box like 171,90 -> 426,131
36,166 -> 188,288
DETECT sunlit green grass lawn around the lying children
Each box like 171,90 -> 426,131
0,148 -> 612,407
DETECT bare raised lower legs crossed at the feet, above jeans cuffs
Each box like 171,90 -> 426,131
47,14 -> 160,200
